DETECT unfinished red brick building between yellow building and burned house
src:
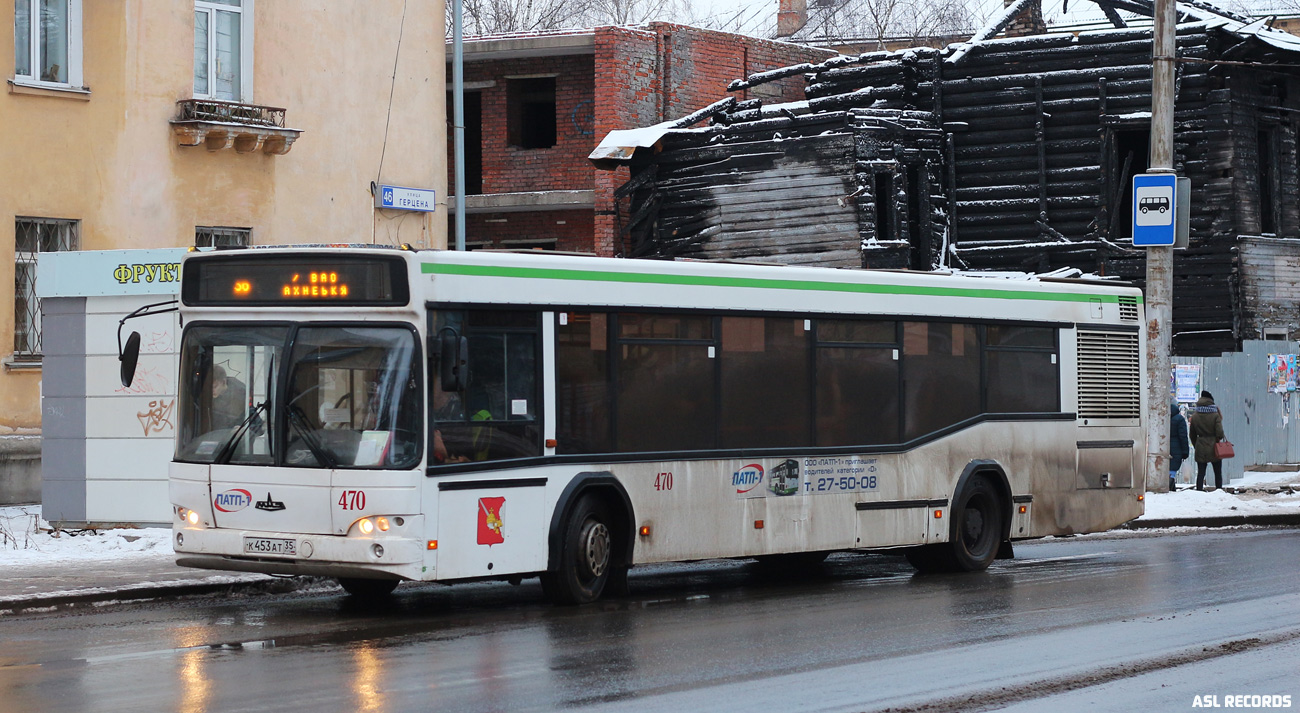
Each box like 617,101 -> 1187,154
447,22 -> 835,255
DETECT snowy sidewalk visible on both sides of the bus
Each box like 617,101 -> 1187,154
0,472 -> 1300,615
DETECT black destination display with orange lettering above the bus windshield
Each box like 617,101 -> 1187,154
181,256 -> 410,306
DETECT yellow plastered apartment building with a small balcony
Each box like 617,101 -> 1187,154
0,0 -> 447,435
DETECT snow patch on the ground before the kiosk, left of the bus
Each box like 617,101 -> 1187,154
0,505 -> 174,570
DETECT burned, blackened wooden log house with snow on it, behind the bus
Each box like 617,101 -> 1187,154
592,0 -> 1300,355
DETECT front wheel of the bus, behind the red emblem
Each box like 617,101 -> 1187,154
542,494 -> 625,604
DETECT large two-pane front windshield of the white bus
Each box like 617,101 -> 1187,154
176,325 -> 423,468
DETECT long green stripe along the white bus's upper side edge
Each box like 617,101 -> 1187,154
420,263 -> 1143,302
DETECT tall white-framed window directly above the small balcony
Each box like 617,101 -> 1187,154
194,0 -> 252,103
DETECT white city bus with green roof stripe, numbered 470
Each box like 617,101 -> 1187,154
124,249 -> 1145,602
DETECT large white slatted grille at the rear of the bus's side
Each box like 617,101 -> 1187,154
1079,329 -> 1141,419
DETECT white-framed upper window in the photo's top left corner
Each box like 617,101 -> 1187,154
13,0 -> 82,87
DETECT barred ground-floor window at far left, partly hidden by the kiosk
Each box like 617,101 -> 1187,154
13,217 -> 77,359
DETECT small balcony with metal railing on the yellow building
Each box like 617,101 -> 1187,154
172,99 -> 302,156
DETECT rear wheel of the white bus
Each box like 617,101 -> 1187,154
906,478 -> 1006,572
